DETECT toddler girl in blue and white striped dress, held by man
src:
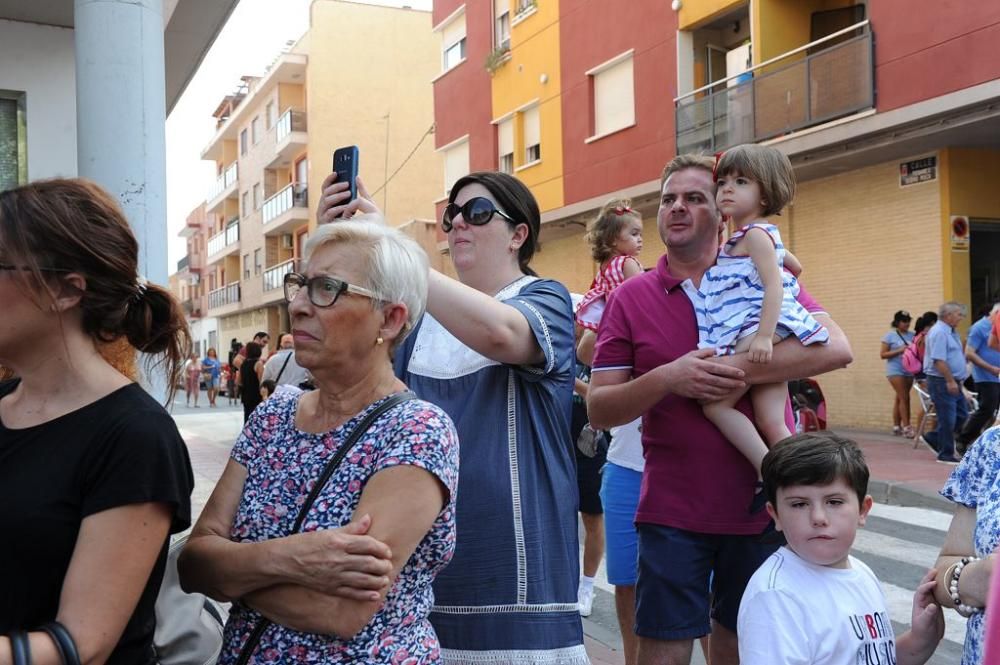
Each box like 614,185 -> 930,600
683,145 -> 830,512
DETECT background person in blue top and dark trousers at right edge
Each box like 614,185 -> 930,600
955,303 -> 1000,455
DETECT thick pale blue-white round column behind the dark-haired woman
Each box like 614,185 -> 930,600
74,0 -> 167,285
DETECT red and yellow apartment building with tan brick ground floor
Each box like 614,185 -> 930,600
433,0 -> 1000,427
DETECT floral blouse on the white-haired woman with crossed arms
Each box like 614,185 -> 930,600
219,393 -> 458,665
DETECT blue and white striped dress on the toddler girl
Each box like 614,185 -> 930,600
681,222 -> 830,356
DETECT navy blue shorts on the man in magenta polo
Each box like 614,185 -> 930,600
635,524 -> 778,640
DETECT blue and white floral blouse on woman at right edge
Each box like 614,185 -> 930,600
941,427 -> 1000,665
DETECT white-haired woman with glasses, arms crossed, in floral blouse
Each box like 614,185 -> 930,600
179,219 -> 458,664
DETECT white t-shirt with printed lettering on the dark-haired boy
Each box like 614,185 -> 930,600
737,547 -> 896,665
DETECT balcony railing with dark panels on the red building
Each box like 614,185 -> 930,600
674,21 -> 875,154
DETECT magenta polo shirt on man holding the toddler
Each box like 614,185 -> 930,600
593,255 -> 823,534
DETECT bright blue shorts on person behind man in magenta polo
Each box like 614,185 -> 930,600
601,462 -> 642,586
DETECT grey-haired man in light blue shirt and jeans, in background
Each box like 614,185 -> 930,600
922,301 -> 969,464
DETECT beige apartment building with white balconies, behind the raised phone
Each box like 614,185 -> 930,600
188,0 -> 441,348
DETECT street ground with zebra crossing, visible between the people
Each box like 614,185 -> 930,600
172,394 -> 965,665
